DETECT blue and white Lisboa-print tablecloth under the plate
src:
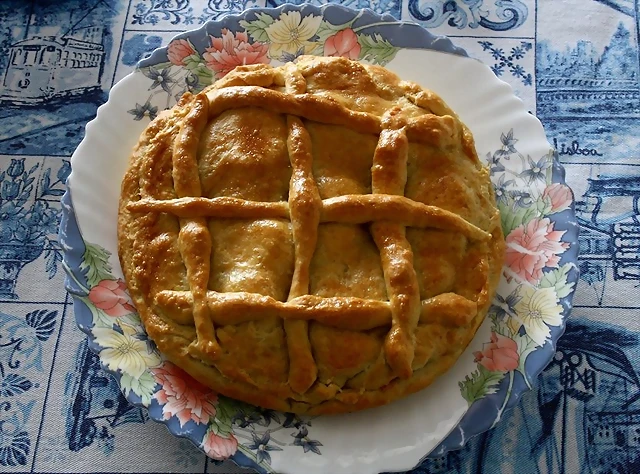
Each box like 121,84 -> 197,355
0,0 -> 640,474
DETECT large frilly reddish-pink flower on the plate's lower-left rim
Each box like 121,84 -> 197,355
151,362 -> 218,426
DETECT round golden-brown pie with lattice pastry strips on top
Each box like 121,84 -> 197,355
118,57 -> 504,414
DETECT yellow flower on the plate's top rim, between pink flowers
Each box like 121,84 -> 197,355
265,11 -> 322,58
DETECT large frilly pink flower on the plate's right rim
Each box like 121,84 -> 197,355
505,218 -> 569,284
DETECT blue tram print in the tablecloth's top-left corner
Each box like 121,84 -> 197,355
0,0 -> 124,156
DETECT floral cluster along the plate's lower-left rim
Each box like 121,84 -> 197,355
63,237 -> 322,472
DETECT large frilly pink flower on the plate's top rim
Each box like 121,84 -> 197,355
202,28 -> 269,79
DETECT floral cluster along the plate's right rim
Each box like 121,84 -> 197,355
459,129 -> 577,420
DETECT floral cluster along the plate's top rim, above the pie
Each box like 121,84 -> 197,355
129,10 -> 400,115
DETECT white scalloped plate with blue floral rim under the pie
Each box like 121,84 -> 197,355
60,5 -> 578,474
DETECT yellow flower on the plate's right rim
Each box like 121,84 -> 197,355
507,287 -> 562,346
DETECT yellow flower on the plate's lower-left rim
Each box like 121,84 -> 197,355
91,324 -> 160,379
